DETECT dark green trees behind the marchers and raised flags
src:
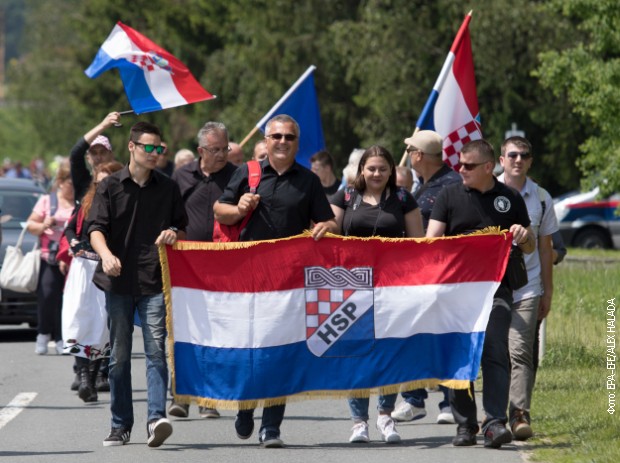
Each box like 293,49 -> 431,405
0,0 -> 589,192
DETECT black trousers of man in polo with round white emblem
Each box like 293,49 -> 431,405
450,285 -> 512,430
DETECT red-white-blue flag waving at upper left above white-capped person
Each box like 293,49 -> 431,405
84,21 -> 215,114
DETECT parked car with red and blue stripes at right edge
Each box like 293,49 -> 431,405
554,187 -> 620,249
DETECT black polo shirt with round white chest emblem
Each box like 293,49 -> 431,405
431,179 -> 530,236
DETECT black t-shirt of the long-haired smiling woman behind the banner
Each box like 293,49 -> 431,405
330,188 -> 418,238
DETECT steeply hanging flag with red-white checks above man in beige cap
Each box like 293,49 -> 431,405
416,11 -> 482,169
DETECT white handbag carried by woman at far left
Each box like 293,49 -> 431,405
0,228 -> 41,293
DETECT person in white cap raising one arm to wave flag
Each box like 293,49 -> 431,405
69,112 -> 121,202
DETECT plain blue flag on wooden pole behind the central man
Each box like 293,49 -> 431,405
256,66 -> 325,168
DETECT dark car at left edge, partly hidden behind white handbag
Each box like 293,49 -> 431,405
0,178 -> 45,327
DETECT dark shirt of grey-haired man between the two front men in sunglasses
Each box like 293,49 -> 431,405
172,159 -> 237,241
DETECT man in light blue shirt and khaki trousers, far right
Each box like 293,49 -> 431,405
498,137 -> 559,440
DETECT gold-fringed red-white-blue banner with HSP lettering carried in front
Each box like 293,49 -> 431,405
160,233 -> 511,409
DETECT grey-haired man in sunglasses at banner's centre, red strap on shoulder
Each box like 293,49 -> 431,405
213,114 -> 337,448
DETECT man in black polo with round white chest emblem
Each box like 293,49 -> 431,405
426,140 -> 535,448
